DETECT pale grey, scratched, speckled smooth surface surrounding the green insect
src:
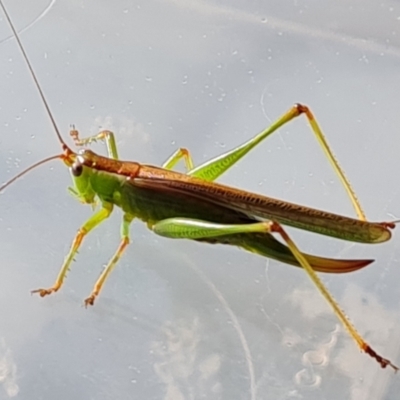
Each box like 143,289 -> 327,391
0,0 -> 400,400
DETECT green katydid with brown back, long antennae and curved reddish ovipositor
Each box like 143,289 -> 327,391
0,1 -> 398,371
